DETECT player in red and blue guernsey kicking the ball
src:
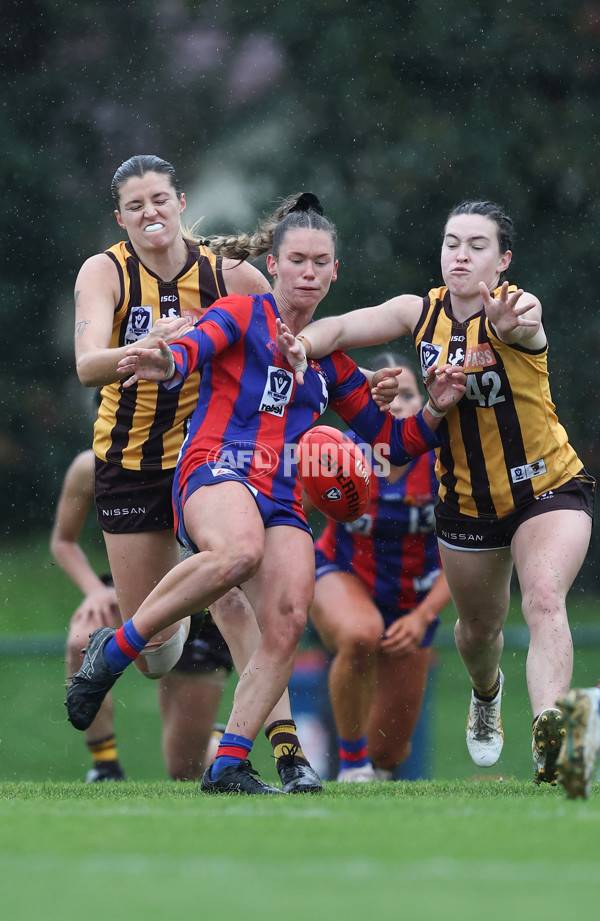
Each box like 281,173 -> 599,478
67,194 -> 464,794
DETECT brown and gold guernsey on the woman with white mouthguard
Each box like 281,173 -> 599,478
94,242 -> 227,470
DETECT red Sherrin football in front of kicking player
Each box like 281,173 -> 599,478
297,425 -> 371,522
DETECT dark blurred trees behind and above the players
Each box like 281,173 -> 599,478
0,0 -> 600,586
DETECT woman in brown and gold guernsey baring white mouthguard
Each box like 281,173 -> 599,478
75,155 -> 328,790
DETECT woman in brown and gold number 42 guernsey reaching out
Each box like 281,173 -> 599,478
280,202 -> 595,784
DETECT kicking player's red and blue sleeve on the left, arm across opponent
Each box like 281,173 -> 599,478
160,294 -> 252,391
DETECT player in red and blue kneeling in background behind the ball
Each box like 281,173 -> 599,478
303,353 -> 450,782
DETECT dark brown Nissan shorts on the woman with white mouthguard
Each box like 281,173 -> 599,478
94,458 -> 175,534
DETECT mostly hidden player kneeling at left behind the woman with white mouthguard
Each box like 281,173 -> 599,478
50,449 -> 233,783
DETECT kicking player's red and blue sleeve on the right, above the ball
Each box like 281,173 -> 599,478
321,352 -> 441,467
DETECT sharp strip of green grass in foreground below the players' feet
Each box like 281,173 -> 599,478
0,781 -> 600,921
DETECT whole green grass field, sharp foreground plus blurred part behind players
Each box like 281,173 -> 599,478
0,544 -> 600,921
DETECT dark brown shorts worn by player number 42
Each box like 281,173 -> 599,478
435,471 -> 596,550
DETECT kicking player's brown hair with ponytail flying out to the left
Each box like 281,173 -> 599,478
208,192 -> 337,261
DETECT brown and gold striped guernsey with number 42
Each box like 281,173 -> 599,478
413,287 -> 582,518
